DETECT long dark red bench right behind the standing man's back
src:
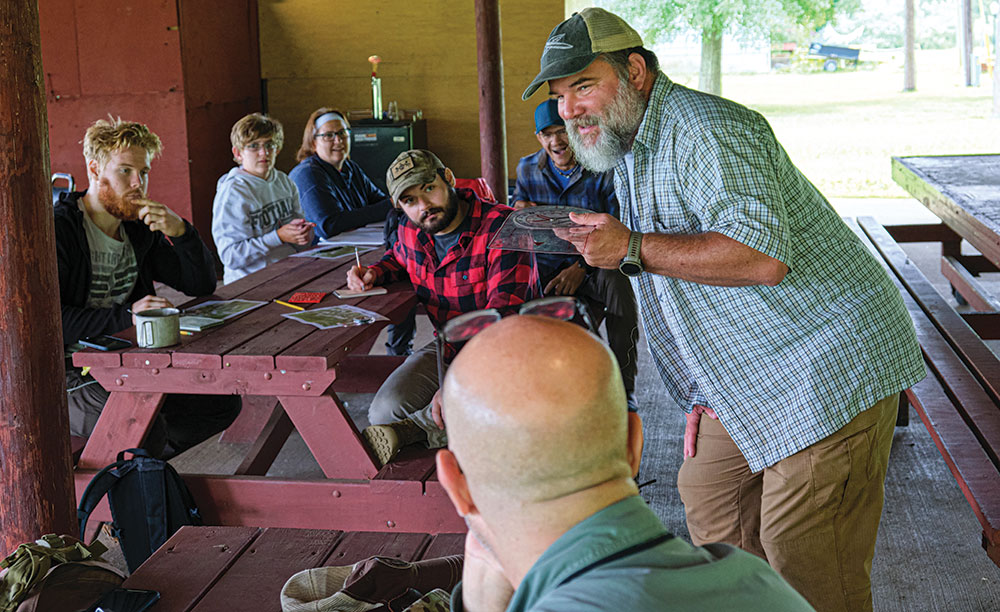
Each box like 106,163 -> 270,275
852,217 -> 1000,565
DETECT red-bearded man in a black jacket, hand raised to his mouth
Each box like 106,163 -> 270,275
53,118 -> 240,457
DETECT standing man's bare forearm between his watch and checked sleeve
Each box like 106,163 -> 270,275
640,232 -> 788,287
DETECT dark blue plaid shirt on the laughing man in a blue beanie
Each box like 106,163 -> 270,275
510,149 -> 618,287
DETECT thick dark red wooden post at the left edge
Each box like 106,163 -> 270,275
0,2 -> 76,555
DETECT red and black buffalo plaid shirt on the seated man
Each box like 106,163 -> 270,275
371,189 -> 538,338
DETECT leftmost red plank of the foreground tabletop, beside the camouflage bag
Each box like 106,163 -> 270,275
123,527 -> 261,612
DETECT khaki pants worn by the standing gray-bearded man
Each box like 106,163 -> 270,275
677,395 -> 899,612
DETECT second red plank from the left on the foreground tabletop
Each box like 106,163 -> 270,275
193,528 -> 342,612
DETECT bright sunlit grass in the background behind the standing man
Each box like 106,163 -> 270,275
669,51 -> 1000,198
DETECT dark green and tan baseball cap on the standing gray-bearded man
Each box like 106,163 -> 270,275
521,8 -> 642,100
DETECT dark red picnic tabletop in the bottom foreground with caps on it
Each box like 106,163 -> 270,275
123,527 -> 465,612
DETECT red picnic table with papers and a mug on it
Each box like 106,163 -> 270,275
73,252 -> 465,533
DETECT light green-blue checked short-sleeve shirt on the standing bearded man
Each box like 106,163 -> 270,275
615,74 -> 925,470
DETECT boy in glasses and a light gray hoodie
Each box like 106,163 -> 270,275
212,113 -> 315,284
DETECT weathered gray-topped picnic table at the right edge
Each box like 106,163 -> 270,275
892,155 -> 1000,312
